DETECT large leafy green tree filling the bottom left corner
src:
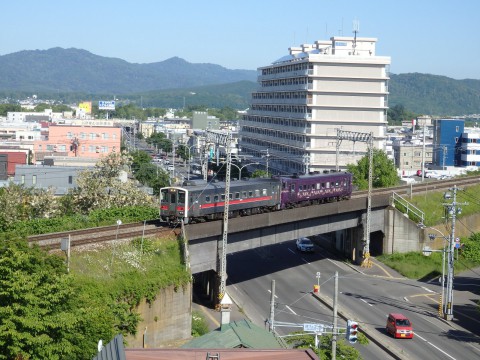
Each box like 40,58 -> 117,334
0,240 -> 114,360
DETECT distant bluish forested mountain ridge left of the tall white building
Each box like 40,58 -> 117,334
0,48 -> 257,95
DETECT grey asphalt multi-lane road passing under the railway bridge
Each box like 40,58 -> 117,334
223,241 -> 480,360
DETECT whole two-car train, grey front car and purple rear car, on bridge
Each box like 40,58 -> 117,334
160,172 -> 353,224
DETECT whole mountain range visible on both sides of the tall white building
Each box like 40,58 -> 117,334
0,47 -> 480,116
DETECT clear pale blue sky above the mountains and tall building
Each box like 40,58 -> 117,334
0,0 -> 480,79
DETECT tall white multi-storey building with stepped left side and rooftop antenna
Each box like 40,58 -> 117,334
239,36 -> 390,174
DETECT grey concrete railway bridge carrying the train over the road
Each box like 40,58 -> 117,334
185,193 -> 423,274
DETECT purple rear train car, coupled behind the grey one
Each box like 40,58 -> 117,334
279,172 -> 352,209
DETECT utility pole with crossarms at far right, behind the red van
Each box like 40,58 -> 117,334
444,185 -> 467,321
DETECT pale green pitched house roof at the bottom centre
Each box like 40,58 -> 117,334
181,319 -> 285,349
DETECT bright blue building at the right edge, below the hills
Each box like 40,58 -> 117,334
432,119 -> 465,170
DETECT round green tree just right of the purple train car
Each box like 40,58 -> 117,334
347,149 -> 399,190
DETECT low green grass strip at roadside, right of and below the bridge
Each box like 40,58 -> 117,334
377,252 -> 480,280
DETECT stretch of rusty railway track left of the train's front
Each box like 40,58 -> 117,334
28,222 -> 179,249
